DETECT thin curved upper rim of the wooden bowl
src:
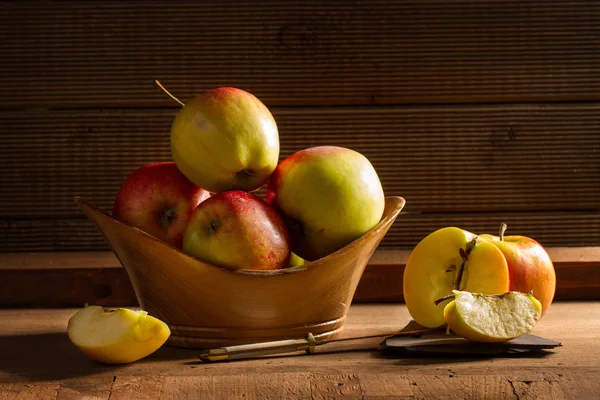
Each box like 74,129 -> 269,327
73,196 -> 406,276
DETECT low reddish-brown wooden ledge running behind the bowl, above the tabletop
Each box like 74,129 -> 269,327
0,247 -> 600,307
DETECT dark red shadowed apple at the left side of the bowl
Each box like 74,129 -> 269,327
113,162 -> 210,248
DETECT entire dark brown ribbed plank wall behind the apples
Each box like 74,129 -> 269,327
0,0 -> 600,252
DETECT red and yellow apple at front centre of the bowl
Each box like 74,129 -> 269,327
183,190 -> 290,270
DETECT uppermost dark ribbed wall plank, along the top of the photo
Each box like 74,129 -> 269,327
0,0 -> 600,108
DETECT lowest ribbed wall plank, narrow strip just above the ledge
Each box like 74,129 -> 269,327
0,211 -> 600,252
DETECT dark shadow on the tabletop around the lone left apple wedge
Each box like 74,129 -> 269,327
0,333 -> 198,381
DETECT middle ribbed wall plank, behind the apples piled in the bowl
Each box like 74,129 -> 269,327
0,103 -> 600,218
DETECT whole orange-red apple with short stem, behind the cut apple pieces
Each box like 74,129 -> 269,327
480,224 -> 556,315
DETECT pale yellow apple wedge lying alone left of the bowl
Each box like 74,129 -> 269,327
67,306 -> 171,364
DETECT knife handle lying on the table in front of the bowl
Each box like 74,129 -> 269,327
199,333 -> 317,361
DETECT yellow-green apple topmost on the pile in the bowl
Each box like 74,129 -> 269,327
171,87 -> 279,193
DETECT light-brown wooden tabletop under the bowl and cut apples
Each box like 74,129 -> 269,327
0,302 -> 600,400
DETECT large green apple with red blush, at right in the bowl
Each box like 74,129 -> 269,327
266,146 -> 385,261
